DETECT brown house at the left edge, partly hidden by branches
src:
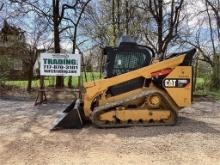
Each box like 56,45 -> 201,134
0,21 -> 28,79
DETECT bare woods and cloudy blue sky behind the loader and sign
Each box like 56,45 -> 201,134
0,0 -> 220,94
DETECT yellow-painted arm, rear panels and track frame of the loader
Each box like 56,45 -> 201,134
84,54 -> 192,120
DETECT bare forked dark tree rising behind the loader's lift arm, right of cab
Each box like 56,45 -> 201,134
137,0 -> 184,58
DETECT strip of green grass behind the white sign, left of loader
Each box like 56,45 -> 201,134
5,72 -> 100,88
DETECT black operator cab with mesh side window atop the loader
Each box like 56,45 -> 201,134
104,36 -> 154,78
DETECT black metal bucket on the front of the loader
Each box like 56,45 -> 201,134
51,99 -> 85,131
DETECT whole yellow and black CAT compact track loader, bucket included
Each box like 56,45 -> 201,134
52,37 -> 196,130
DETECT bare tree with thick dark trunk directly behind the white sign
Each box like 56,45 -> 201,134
10,0 -> 84,88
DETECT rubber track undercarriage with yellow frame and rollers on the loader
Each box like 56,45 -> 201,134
91,89 -> 178,128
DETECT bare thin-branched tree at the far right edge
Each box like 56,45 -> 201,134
179,0 -> 220,89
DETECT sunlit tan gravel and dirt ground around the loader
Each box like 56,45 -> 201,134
0,99 -> 220,165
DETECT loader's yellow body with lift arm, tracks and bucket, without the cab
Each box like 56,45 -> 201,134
53,50 -> 192,130
